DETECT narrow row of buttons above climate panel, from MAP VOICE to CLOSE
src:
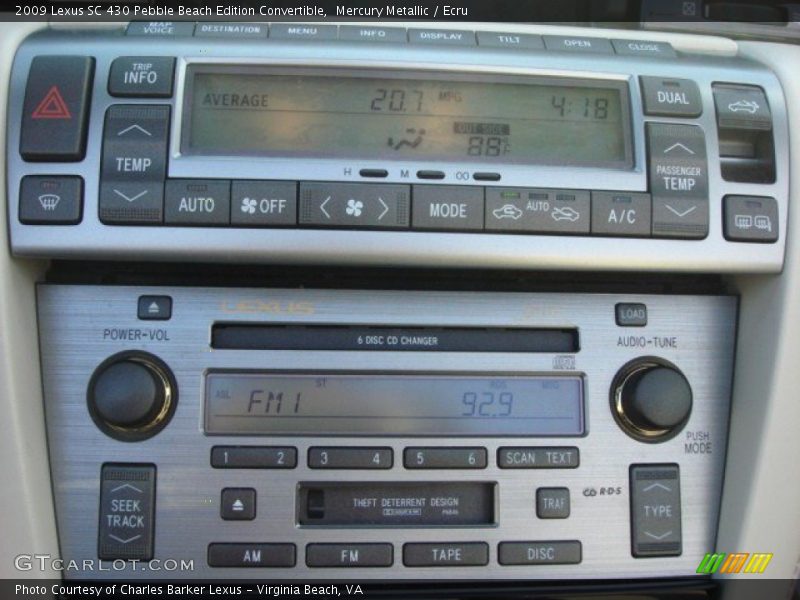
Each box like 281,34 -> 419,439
127,22 -> 676,58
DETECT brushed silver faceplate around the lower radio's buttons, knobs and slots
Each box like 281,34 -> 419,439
38,285 -> 736,579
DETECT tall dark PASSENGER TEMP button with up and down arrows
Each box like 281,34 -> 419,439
647,123 -> 709,239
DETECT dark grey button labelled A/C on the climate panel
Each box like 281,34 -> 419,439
592,192 -> 652,237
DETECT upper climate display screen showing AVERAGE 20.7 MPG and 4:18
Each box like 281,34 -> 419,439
181,65 -> 633,169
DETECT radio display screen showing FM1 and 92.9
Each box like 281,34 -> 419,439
205,373 -> 584,437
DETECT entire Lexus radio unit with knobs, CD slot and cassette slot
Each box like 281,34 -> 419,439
38,285 -> 736,580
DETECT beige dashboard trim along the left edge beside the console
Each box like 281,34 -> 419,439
0,23 -> 58,578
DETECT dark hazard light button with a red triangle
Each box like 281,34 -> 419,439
19,56 -> 94,162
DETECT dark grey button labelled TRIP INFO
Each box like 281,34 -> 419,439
108,56 -> 175,98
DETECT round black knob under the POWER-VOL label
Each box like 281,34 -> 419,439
87,352 -> 178,441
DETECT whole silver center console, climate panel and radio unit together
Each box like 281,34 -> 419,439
7,22 -> 789,581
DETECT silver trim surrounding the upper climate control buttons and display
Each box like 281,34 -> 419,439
7,31 -> 789,273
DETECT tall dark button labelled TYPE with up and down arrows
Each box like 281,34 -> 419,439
630,465 -> 681,558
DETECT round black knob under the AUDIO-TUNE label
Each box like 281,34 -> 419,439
611,358 -> 692,442
